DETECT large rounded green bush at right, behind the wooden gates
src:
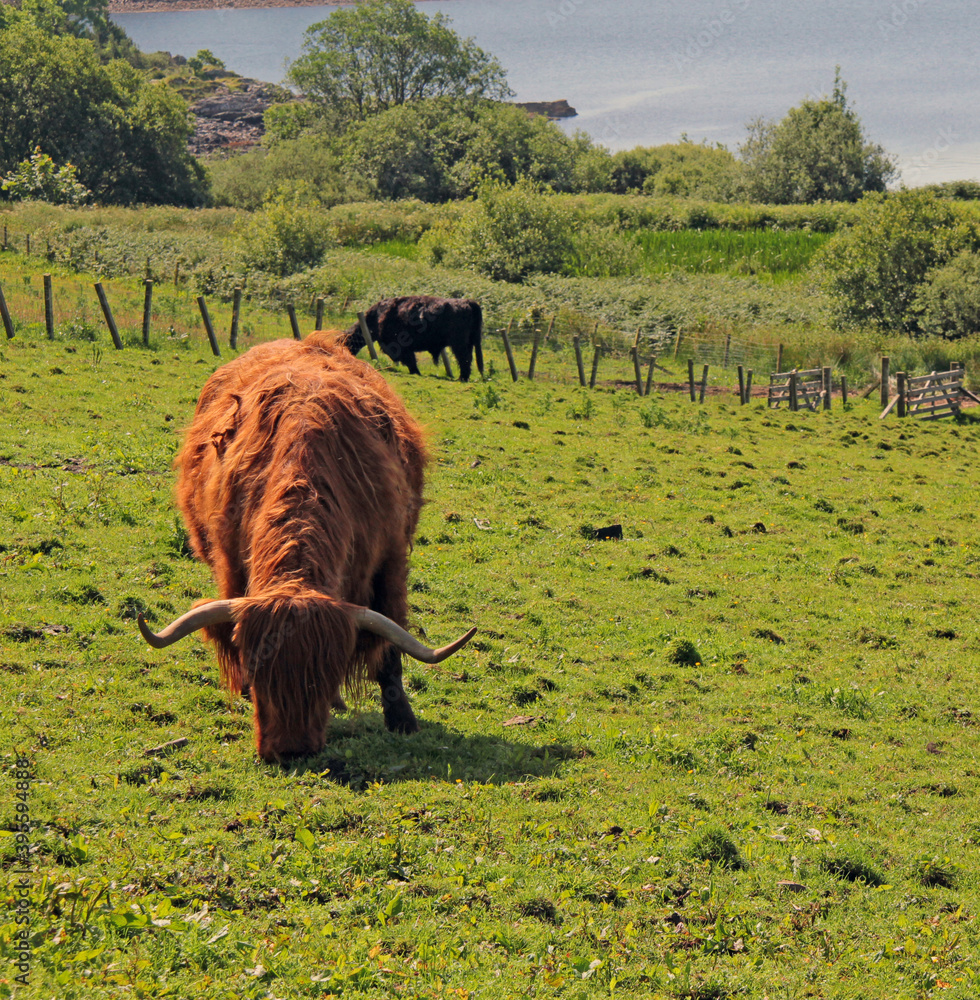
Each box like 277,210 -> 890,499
814,191 -> 980,332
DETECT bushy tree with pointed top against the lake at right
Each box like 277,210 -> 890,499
739,67 -> 896,205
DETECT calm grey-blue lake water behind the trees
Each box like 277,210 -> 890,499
113,0 -> 980,186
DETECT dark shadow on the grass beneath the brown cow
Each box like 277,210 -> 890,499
284,715 -> 590,791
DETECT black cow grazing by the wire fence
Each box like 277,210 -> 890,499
346,295 -> 483,382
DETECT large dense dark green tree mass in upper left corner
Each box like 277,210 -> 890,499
0,16 -> 206,204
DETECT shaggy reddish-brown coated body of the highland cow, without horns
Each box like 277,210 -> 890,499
176,332 -> 426,760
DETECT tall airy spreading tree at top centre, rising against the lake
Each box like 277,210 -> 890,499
288,0 -> 510,129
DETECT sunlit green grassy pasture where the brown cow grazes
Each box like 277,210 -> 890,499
0,316 -> 980,1000
